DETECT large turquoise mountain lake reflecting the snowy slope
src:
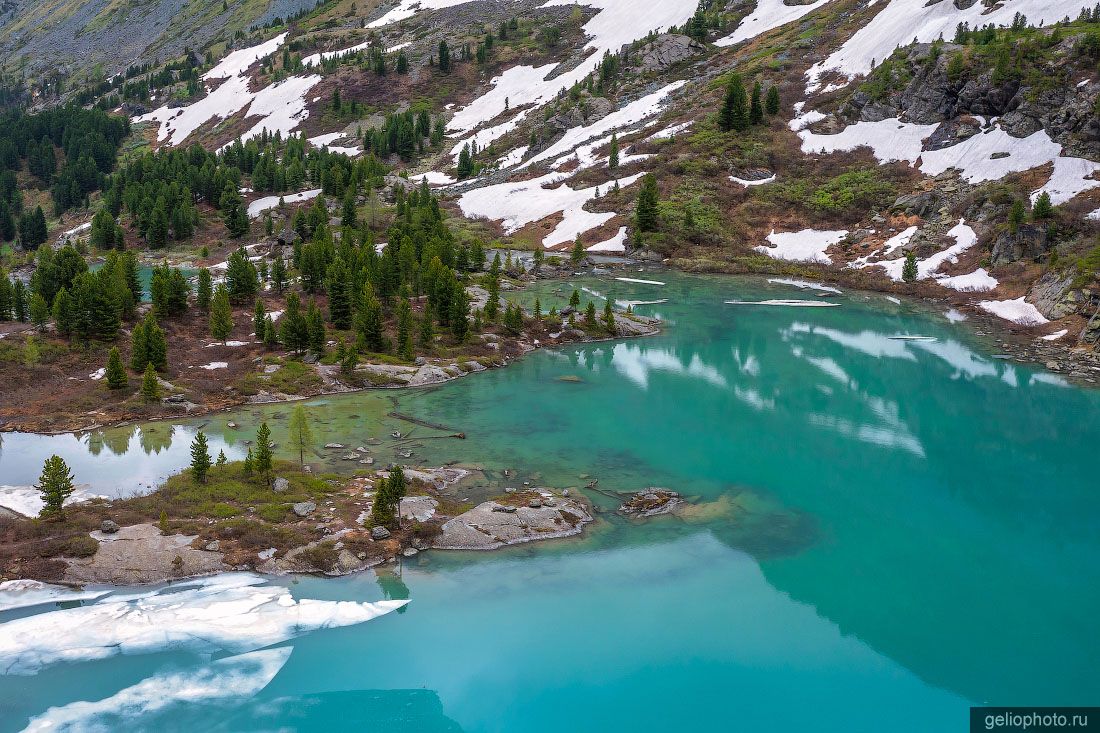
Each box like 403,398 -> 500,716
0,272 -> 1100,733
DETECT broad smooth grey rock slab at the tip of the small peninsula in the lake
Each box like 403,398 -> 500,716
432,492 -> 592,550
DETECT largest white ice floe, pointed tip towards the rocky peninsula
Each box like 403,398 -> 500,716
0,573 -> 408,675
